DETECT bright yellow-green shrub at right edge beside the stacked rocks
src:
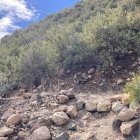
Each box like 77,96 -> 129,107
125,75 -> 140,105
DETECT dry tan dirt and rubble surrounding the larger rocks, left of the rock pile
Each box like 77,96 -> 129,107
0,90 -> 138,140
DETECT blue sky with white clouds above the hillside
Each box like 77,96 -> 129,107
0,0 -> 80,38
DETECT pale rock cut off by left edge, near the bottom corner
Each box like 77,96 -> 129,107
0,127 -> 14,137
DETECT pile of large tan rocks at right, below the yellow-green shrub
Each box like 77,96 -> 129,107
111,94 -> 139,136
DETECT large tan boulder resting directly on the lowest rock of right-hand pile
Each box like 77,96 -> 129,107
118,107 -> 136,122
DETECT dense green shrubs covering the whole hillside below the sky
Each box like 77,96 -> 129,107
0,0 -> 140,95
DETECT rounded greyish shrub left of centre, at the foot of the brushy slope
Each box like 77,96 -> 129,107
20,48 -> 48,86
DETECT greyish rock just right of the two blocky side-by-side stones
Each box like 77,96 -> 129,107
112,101 -> 124,114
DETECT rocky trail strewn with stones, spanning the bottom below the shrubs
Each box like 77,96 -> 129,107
0,89 -> 137,140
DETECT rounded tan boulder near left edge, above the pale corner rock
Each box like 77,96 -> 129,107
6,114 -> 22,126
